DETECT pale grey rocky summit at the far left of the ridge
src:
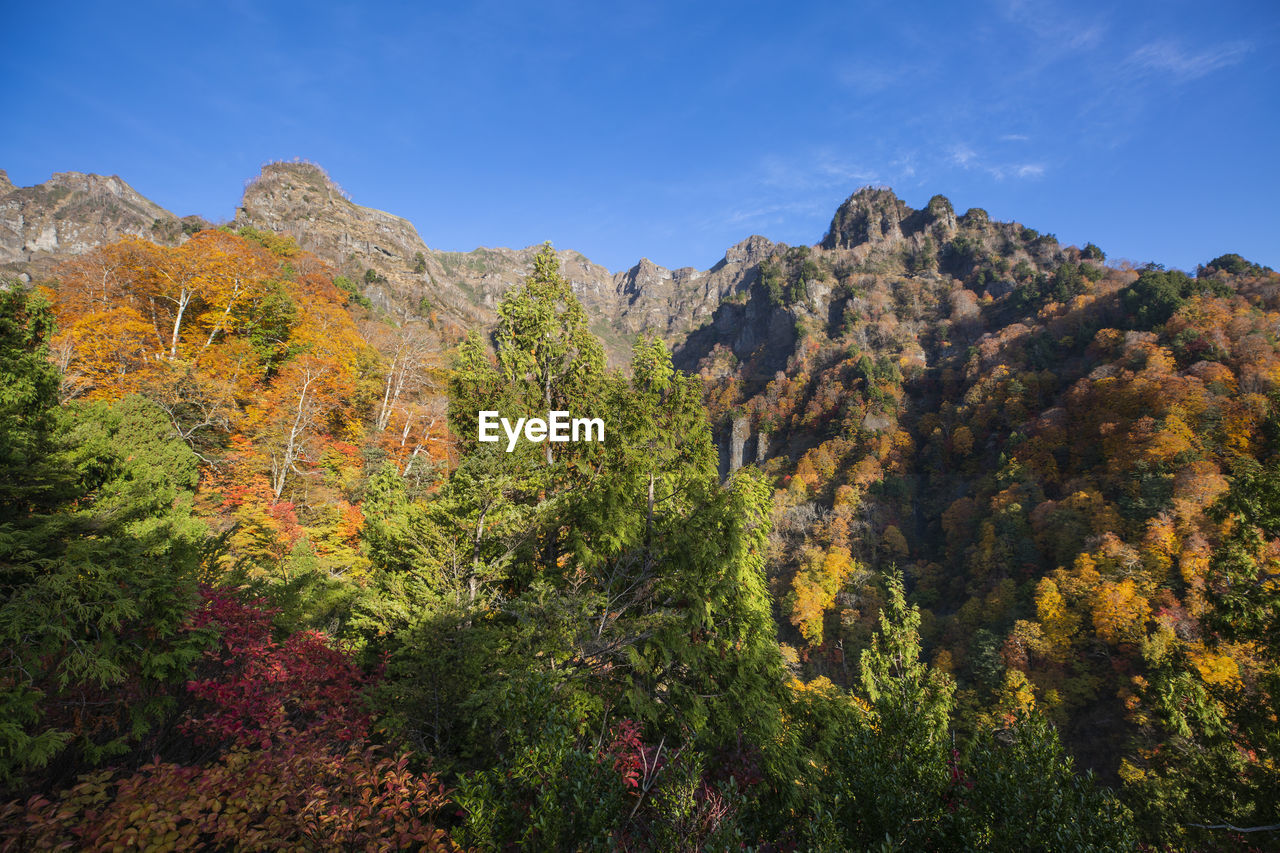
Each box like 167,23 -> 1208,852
0,172 -> 186,269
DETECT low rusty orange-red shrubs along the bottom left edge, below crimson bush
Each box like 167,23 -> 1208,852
0,738 -> 457,850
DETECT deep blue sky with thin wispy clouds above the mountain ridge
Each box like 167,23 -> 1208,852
0,0 -> 1280,270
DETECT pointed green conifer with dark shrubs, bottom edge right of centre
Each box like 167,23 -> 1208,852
756,573 -> 1134,852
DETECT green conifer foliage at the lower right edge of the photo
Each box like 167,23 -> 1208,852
1121,450 -> 1280,848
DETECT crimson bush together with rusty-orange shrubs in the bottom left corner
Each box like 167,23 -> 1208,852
0,589 -> 457,850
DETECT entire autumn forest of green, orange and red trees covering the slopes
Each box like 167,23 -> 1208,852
0,202 -> 1280,850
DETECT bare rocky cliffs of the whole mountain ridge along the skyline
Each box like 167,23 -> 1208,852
0,163 -> 1079,375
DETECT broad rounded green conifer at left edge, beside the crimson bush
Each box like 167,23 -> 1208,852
0,386 -> 207,780
